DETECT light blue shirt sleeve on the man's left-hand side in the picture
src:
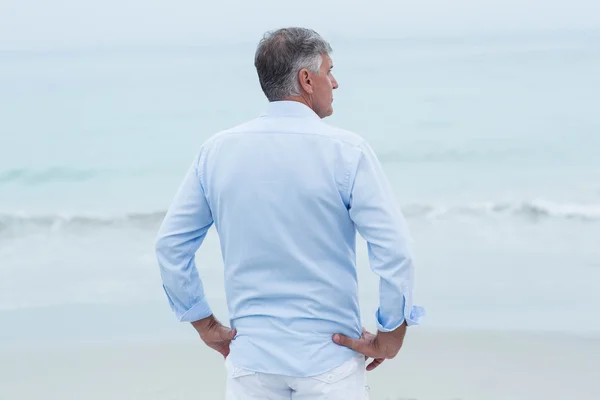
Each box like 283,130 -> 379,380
155,152 -> 213,322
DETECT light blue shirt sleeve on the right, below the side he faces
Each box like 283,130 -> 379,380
349,142 -> 425,332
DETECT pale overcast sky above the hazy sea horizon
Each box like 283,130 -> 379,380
0,0 -> 600,49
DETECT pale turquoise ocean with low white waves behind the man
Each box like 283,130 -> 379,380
0,32 -> 600,400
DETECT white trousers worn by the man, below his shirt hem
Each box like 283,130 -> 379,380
225,356 -> 369,400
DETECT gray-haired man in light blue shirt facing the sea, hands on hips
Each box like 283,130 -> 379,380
156,28 -> 422,400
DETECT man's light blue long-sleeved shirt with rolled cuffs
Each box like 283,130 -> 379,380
156,101 -> 423,377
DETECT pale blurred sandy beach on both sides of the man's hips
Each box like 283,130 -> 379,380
0,328 -> 600,400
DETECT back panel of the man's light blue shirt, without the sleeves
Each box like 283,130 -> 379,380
204,102 -> 363,376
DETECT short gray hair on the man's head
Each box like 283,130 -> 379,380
254,28 -> 332,101
